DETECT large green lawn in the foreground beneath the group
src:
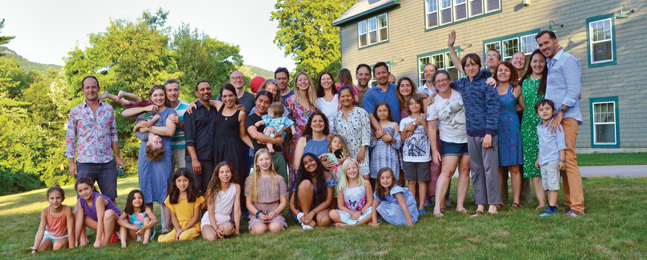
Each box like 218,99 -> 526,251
0,177 -> 647,259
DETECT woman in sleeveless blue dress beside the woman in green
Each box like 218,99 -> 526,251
494,61 -> 523,209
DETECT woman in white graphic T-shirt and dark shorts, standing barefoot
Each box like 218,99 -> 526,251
427,70 -> 470,217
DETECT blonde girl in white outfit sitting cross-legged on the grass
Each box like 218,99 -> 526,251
329,158 -> 373,227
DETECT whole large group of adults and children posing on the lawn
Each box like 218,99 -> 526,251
33,31 -> 584,252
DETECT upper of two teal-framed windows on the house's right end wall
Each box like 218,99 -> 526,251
586,14 -> 616,67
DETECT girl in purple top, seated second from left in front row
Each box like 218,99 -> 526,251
74,177 -> 121,247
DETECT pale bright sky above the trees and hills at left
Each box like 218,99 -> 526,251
0,0 -> 296,71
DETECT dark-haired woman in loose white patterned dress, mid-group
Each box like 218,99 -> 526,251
334,87 -> 371,180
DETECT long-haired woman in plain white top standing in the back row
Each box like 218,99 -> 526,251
317,72 -> 339,133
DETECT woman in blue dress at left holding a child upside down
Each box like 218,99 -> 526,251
132,85 -> 177,232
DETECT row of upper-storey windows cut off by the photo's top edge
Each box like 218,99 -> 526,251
424,0 -> 501,29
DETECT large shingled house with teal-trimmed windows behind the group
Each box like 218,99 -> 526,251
332,0 -> 647,153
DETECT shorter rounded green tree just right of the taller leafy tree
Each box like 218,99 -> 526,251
170,24 -> 243,100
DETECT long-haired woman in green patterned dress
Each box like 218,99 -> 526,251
517,50 -> 548,209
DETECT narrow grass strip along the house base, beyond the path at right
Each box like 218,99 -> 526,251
577,153 -> 647,166
